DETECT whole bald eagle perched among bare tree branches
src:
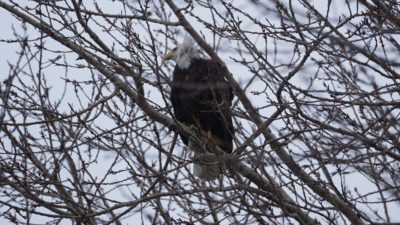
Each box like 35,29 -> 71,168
164,38 -> 234,180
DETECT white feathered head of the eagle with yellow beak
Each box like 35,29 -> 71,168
163,36 -> 200,69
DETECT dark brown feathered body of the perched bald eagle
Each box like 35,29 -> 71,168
171,59 -> 234,153
